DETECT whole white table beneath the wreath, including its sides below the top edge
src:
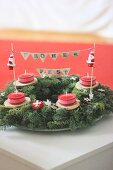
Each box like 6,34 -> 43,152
0,116 -> 113,170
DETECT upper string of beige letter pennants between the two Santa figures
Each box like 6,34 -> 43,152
20,48 -> 92,62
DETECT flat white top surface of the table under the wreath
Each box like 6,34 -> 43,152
0,116 -> 113,170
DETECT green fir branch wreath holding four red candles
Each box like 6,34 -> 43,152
0,75 -> 113,131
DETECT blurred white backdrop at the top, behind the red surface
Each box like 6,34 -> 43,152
0,0 -> 113,37
